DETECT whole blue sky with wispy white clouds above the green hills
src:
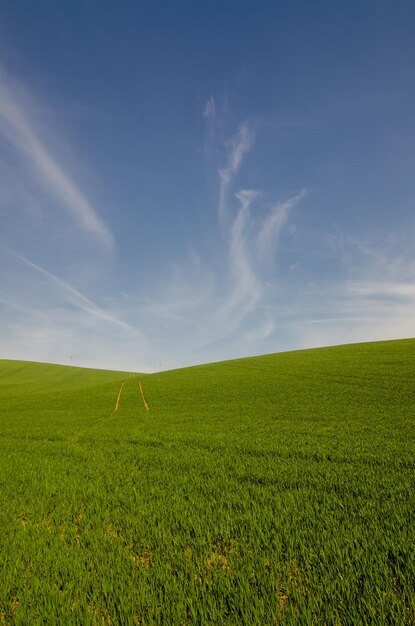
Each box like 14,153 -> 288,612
0,0 -> 415,371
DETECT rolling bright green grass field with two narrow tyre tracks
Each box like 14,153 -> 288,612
0,340 -> 415,626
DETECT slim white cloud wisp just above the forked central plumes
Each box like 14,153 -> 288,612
218,124 -> 254,223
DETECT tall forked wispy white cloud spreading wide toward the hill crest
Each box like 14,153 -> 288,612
124,117 -> 305,362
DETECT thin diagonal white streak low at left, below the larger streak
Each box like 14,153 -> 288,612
9,250 -> 136,332
